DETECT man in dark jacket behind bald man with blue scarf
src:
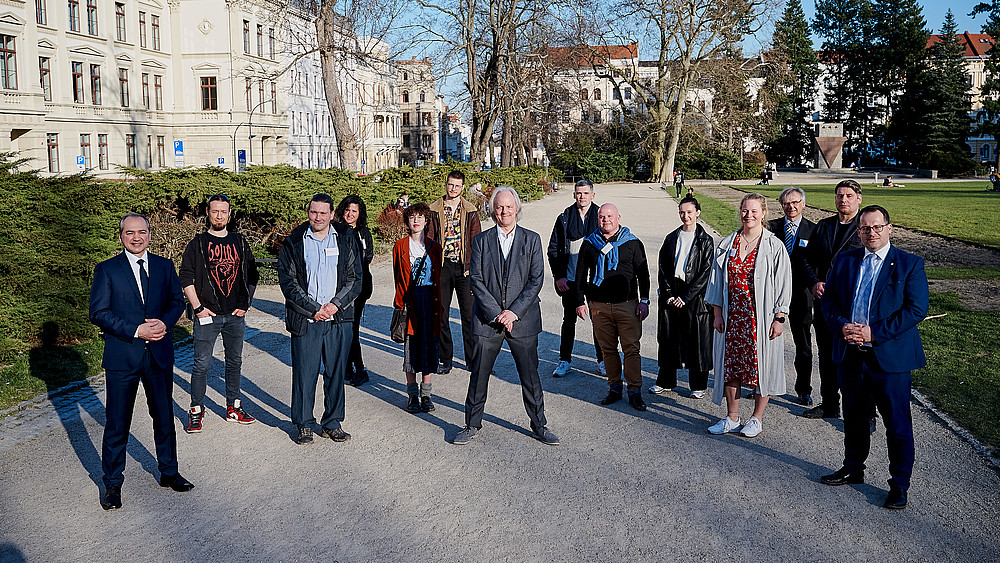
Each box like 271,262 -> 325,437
548,180 -> 607,377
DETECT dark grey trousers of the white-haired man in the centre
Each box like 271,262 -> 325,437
465,332 -> 545,430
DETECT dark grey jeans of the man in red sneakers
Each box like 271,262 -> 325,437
191,315 -> 247,407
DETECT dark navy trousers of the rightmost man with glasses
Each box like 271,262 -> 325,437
839,346 -> 914,490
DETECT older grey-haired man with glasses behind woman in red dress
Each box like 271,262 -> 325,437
767,187 -> 816,407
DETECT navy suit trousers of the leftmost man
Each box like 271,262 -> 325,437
101,348 -> 177,487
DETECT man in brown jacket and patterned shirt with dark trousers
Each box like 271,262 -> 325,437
427,170 -> 483,375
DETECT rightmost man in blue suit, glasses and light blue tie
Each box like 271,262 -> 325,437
820,205 -> 928,510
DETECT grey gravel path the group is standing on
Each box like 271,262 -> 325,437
0,184 -> 1000,562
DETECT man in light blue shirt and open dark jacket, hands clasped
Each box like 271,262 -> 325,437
278,194 -> 362,445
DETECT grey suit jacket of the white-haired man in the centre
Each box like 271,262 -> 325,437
469,226 -> 545,338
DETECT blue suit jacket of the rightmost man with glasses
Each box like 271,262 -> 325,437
820,246 -> 928,373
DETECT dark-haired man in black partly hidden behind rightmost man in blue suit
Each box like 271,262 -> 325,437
792,180 -> 861,418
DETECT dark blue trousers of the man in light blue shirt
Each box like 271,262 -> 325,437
292,322 -> 353,429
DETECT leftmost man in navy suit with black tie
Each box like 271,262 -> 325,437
90,213 -> 194,510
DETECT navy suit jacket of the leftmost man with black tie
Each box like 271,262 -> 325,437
90,252 -> 184,372
